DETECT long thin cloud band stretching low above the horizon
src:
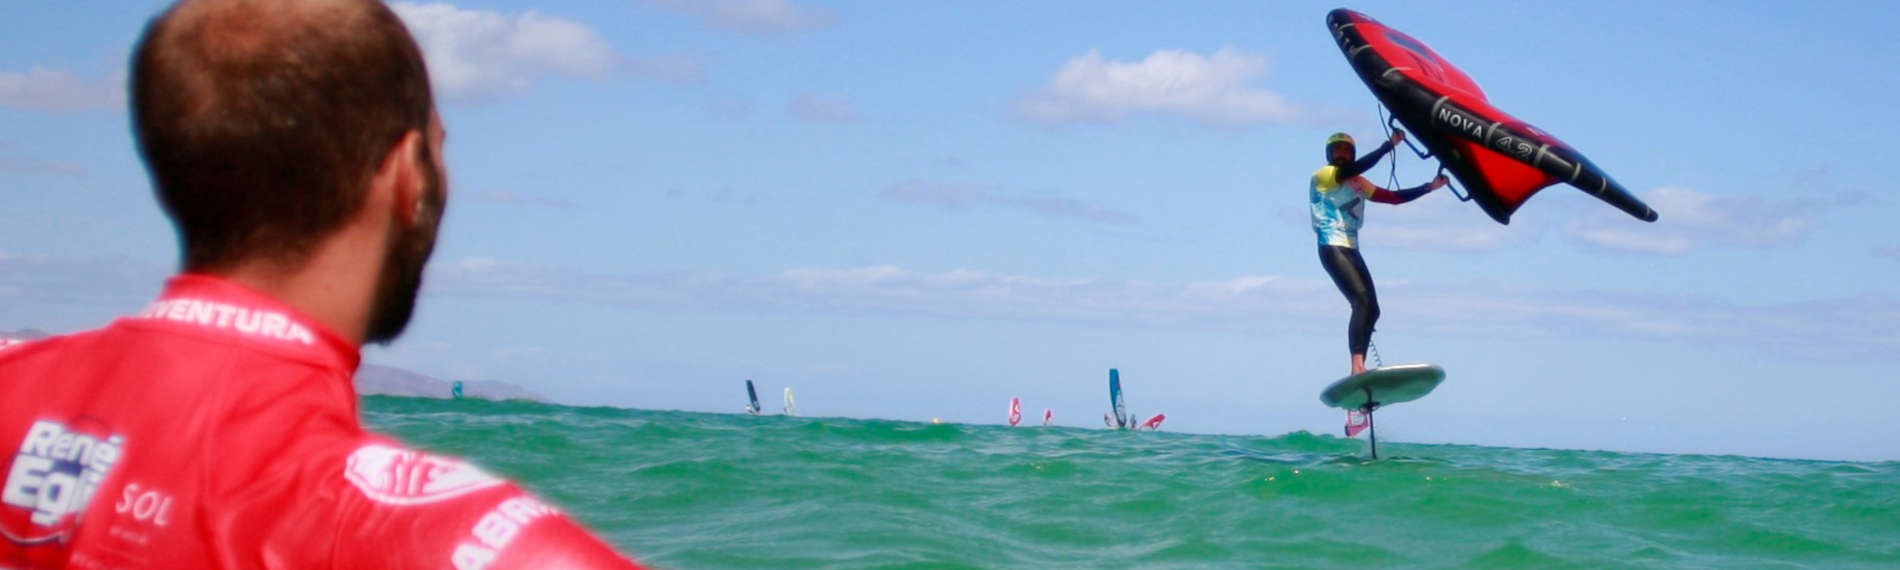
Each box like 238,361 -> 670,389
429,262 -> 1900,357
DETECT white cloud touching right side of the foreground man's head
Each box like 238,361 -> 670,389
390,2 -> 619,97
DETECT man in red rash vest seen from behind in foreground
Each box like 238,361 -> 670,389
0,0 -> 638,568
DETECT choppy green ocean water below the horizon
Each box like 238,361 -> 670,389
363,397 -> 1900,568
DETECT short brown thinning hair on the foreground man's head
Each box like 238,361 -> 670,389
131,0 -> 433,270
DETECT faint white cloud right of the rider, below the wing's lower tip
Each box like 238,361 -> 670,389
1569,186 -> 1815,255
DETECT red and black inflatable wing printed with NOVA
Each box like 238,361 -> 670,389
1326,8 -> 1657,224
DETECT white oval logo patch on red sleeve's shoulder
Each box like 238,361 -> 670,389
344,443 -> 502,505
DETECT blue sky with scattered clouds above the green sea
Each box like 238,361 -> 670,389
0,0 -> 1900,460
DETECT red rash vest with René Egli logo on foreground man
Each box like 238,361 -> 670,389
0,276 -> 638,570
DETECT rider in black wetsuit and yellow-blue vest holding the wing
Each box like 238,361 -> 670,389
1307,129 -> 1450,374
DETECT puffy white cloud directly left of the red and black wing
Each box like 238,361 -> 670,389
1015,48 -> 1298,127
